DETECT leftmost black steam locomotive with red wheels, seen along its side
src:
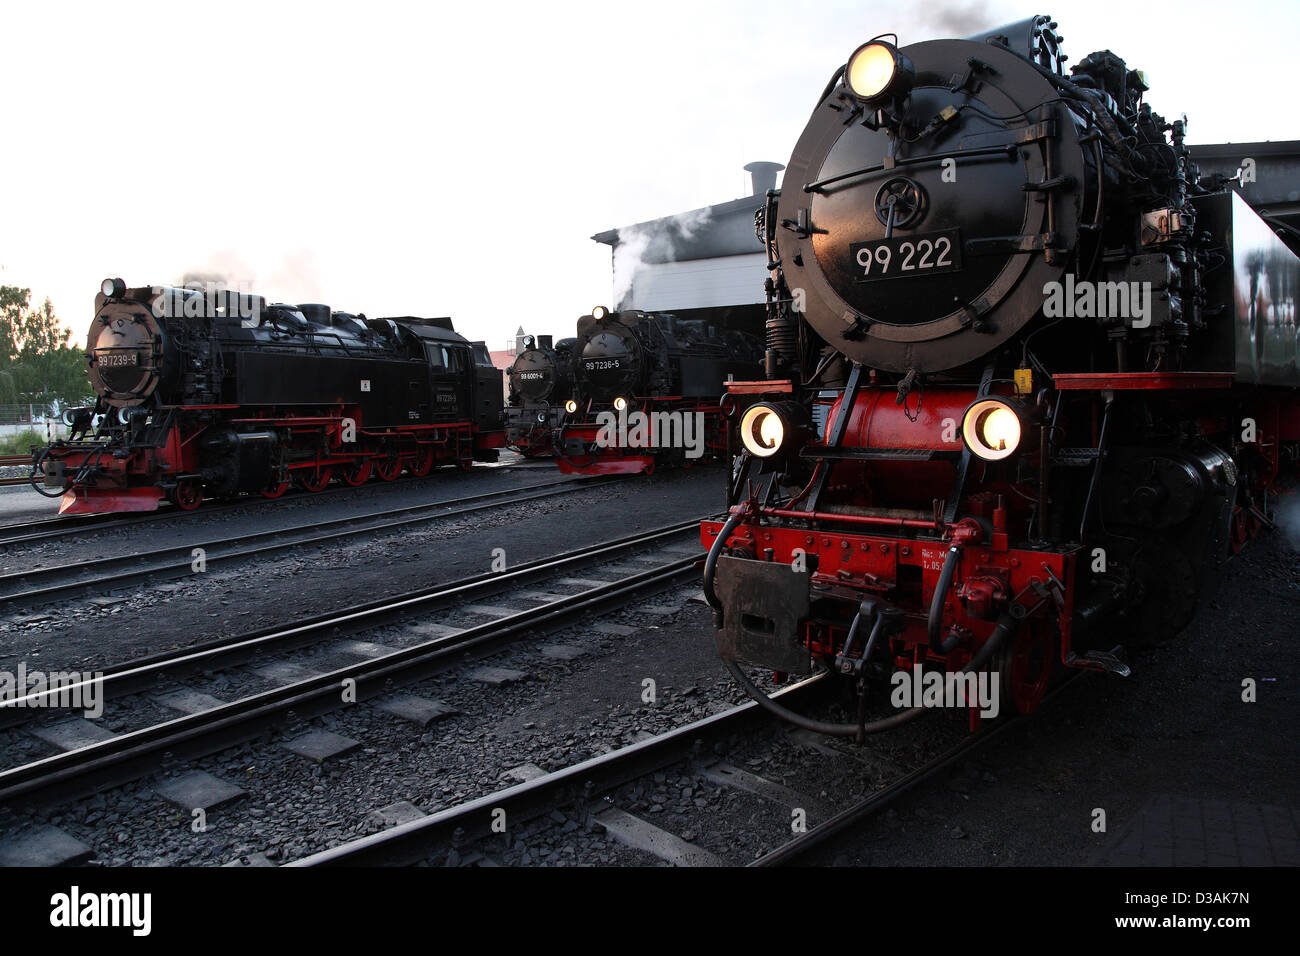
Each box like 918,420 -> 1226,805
33,278 -> 504,514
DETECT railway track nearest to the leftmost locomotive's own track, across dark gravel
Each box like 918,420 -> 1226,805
0,479 -> 618,607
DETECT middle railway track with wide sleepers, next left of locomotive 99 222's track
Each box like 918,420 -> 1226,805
0,519 -> 701,804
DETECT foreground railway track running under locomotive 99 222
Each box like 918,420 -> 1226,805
297,675 -> 1076,868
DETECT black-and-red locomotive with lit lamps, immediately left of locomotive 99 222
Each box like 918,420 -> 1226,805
555,306 -> 762,475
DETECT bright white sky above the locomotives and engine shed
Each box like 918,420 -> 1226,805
0,0 -> 1300,349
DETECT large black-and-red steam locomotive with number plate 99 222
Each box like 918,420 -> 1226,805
702,17 -> 1300,739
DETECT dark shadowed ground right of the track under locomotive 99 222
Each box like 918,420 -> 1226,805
820,535 -> 1300,866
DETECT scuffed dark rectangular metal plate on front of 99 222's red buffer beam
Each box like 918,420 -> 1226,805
714,555 -> 813,674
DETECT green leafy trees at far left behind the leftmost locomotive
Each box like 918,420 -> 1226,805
0,285 -> 94,405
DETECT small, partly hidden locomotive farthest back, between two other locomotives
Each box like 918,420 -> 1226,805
506,336 -> 575,458
